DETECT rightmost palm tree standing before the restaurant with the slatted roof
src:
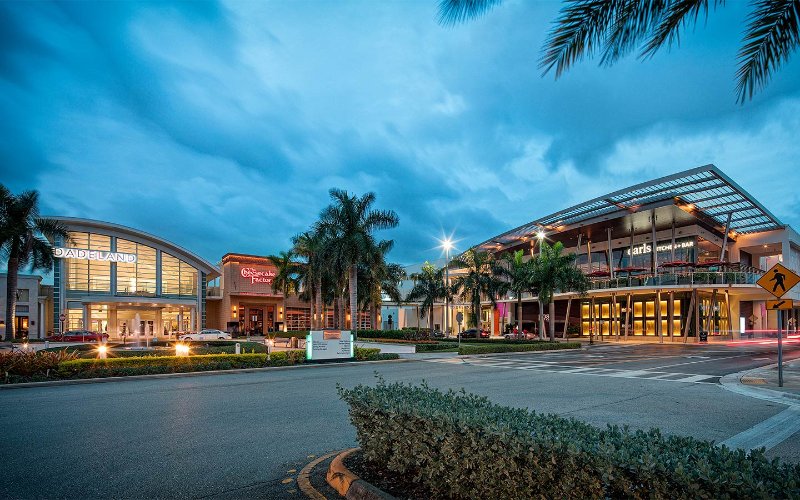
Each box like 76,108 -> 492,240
531,240 -> 589,341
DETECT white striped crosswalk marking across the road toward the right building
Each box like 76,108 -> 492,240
420,358 -> 719,384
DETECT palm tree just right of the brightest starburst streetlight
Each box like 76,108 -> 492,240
450,248 -> 504,327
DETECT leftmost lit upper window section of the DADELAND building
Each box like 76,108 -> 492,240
65,232 -> 111,293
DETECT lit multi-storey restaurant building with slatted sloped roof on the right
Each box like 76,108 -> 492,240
468,165 -> 800,341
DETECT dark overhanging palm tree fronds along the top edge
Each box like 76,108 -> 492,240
439,0 -> 800,103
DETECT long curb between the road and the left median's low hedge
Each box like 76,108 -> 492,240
0,358 -> 414,391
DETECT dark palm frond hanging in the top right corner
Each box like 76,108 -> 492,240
736,0 -> 800,103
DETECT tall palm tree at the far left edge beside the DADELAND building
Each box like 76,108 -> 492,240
0,184 -> 69,341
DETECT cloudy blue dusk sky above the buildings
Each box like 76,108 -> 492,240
0,0 -> 800,270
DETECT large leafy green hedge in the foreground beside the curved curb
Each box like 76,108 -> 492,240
338,380 -> 800,499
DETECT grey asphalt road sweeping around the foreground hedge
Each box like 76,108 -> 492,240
0,346 -> 800,498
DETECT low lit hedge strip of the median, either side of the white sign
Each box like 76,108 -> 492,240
0,347 -> 398,383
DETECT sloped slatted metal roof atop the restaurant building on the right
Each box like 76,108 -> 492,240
479,165 -> 784,249
